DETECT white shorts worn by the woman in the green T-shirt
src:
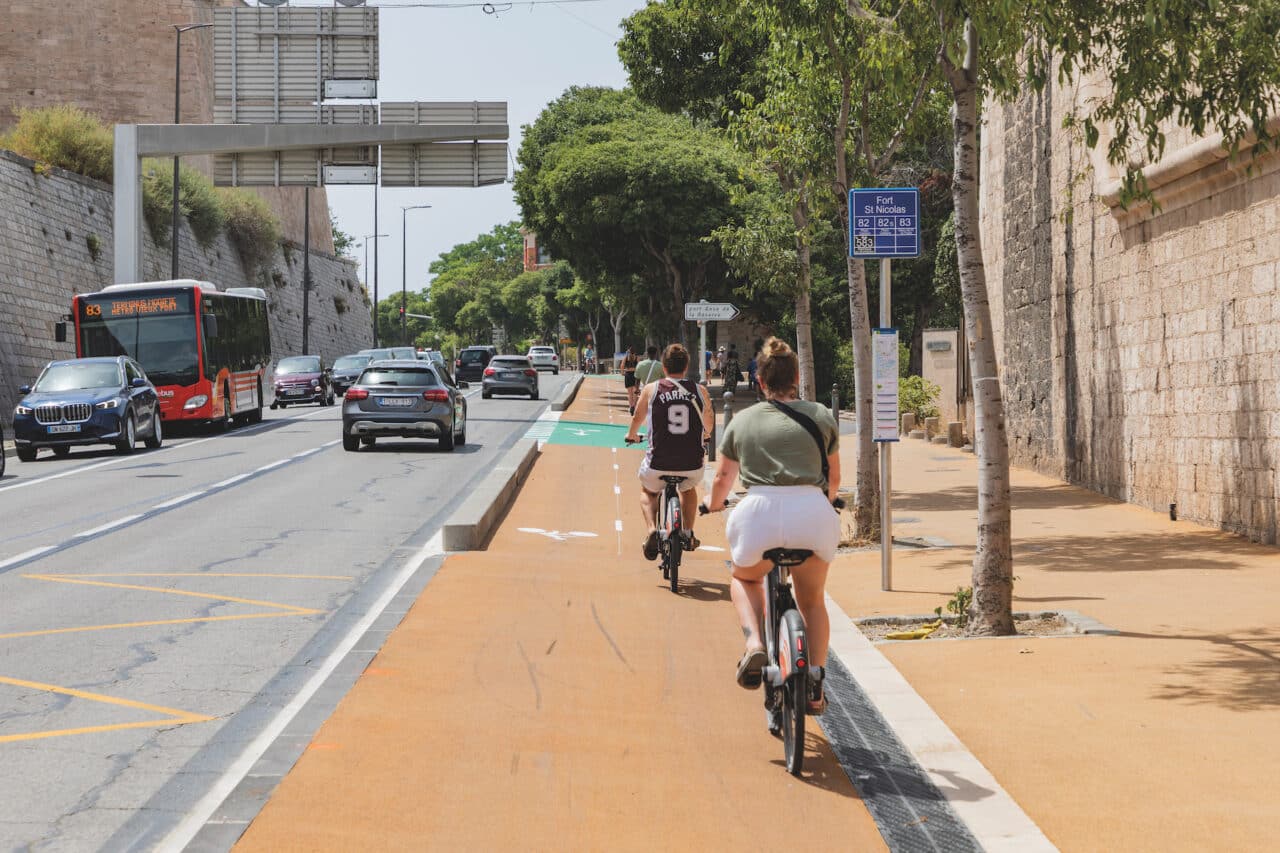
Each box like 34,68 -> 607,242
724,485 -> 840,566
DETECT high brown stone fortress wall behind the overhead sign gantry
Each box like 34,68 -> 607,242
0,0 -> 333,251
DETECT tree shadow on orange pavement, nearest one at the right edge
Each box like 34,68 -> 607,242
1119,628 -> 1280,711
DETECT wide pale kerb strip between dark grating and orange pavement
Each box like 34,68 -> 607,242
827,596 -> 1057,853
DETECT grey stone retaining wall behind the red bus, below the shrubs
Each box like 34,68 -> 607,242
0,151 -> 372,421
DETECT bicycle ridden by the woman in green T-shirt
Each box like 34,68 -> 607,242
698,498 -> 845,776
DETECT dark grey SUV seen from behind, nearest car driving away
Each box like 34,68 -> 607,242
342,359 -> 468,451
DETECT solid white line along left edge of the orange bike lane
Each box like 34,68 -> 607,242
156,533 -> 444,853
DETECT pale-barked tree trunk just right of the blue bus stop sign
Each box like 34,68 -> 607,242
941,20 -> 1014,635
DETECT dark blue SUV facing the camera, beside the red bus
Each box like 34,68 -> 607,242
13,356 -> 164,462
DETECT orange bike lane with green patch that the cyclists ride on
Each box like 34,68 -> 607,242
232,379 -> 886,850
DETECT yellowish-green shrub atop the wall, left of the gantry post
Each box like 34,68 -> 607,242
0,104 -> 114,182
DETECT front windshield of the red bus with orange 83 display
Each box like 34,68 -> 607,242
79,293 -> 200,386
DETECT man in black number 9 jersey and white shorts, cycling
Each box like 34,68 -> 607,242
627,343 -> 714,560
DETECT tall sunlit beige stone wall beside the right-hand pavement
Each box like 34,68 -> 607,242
982,71 -> 1280,543
